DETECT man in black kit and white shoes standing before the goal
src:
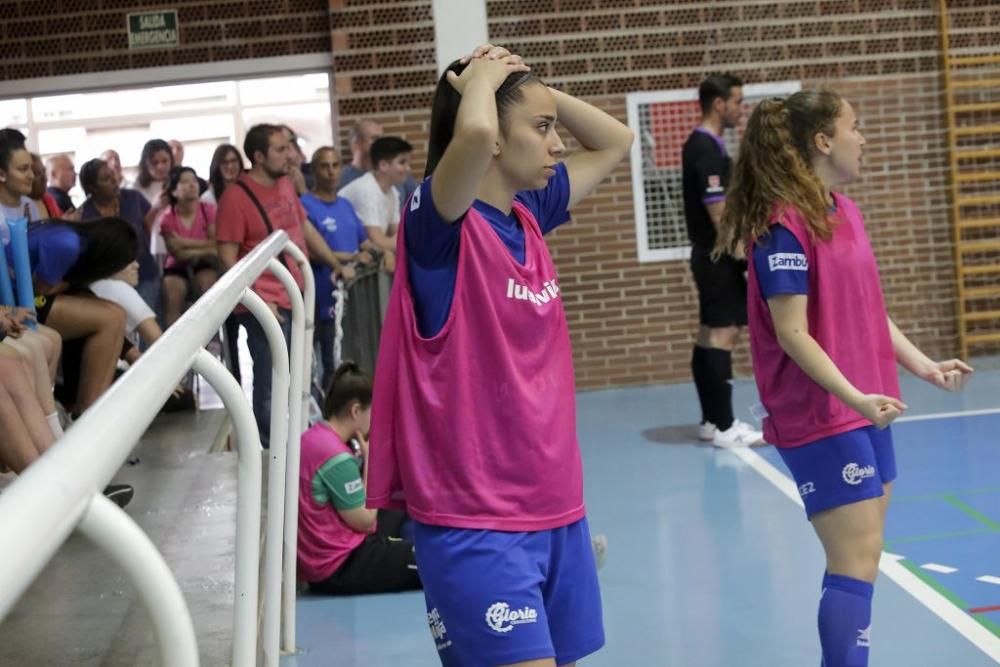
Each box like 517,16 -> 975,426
681,74 -> 763,447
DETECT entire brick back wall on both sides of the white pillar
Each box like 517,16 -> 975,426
0,0 -> 1000,387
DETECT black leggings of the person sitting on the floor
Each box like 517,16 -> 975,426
309,511 -> 423,595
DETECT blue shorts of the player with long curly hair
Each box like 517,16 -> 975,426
778,426 -> 896,517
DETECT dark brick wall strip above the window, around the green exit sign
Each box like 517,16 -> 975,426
0,0 -> 330,81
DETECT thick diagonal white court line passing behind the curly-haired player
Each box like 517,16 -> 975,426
729,444 -> 1000,663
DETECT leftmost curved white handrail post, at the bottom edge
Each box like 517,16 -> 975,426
77,493 -> 198,667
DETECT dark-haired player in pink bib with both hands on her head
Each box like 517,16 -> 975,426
368,45 -> 633,667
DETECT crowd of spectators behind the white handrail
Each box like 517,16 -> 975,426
0,121 -> 415,520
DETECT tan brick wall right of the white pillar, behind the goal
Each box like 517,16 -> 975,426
488,0 -> 1000,387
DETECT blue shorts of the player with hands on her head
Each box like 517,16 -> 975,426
414,519 -> 604,667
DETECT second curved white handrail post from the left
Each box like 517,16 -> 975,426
192,349 -> 263,667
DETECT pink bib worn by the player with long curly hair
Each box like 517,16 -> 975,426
747,194 -> 899,447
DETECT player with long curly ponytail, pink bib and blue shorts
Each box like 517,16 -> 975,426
716,90 -> 972,667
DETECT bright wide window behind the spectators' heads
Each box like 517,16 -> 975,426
0,72 -> 334,204
